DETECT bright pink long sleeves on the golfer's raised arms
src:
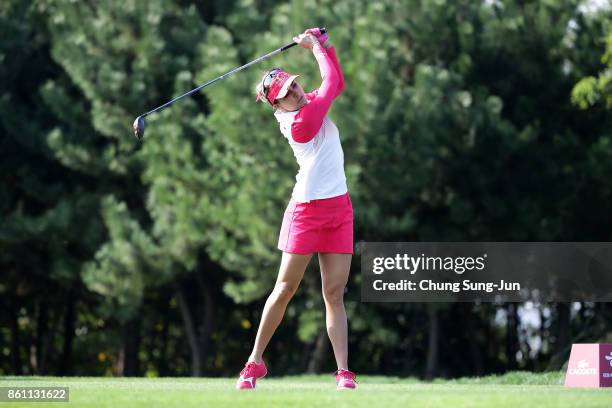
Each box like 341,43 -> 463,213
291,44 -> 344,143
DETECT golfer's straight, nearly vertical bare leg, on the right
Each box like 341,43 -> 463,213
319,253 -> 352,370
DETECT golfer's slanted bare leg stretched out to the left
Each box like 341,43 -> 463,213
248,252 -> 312,363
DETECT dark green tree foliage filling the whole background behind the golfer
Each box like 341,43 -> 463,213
0,0 -> 612,377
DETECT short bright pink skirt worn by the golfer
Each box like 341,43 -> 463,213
278,192 -> 353,254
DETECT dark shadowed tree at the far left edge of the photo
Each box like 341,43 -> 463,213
0,1 -> 102,374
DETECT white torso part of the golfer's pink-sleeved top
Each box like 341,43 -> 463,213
274,110 -> 348,203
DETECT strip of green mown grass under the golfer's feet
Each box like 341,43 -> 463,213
0,372 -> 612,408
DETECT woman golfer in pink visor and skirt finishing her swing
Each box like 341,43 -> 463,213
236,28 -> 356,389
